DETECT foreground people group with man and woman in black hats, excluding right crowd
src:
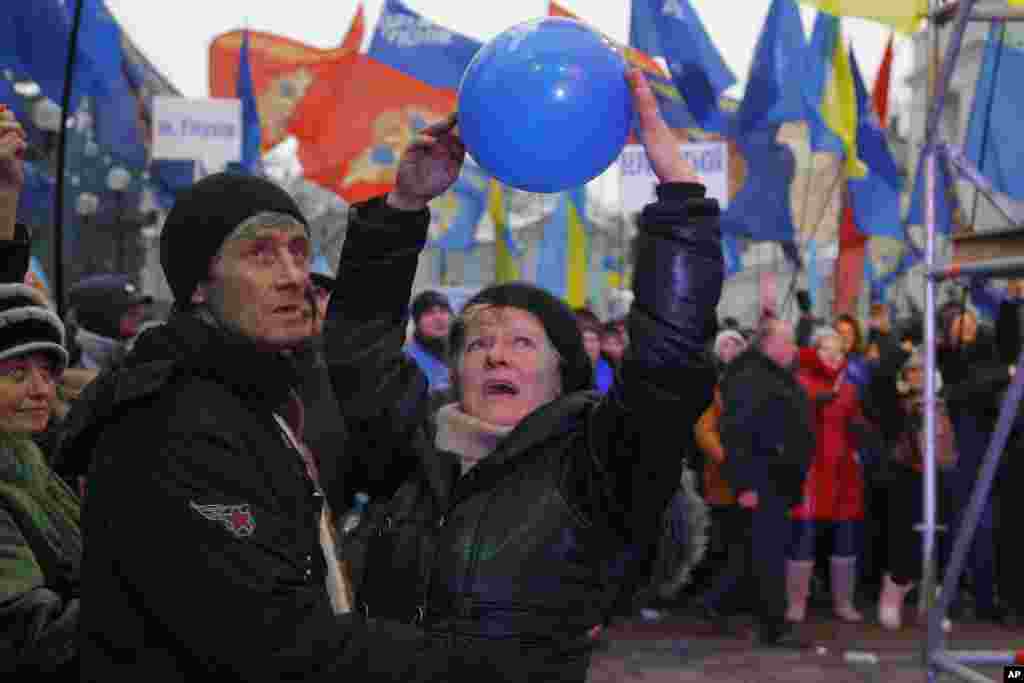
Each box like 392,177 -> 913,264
0,71 -> 723,681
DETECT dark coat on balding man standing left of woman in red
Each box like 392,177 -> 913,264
719,349 -> 814,505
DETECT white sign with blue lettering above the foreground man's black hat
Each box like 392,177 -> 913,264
153,95 -> 242,168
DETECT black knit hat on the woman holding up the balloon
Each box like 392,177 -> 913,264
450,283 -> 594,393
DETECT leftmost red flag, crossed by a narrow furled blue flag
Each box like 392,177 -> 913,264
209,4 -> 366,151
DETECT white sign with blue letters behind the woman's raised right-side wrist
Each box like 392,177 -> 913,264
618,142 -> 729,215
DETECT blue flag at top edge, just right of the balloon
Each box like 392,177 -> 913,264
630,0 -> 736,133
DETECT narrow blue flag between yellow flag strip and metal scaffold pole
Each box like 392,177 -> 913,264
848,49 -> 903,240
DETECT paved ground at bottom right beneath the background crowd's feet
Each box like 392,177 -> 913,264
590,606 -> 1024,683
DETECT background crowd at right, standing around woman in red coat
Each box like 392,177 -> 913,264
695,292 -> 1024,640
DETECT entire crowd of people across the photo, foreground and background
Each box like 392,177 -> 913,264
0,61 -> 1024,681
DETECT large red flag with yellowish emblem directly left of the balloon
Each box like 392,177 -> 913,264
289,54 -> 456,203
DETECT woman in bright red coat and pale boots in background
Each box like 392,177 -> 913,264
786,330 -> 864,622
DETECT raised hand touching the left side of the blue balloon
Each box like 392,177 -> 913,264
387,114 -> 466,211
